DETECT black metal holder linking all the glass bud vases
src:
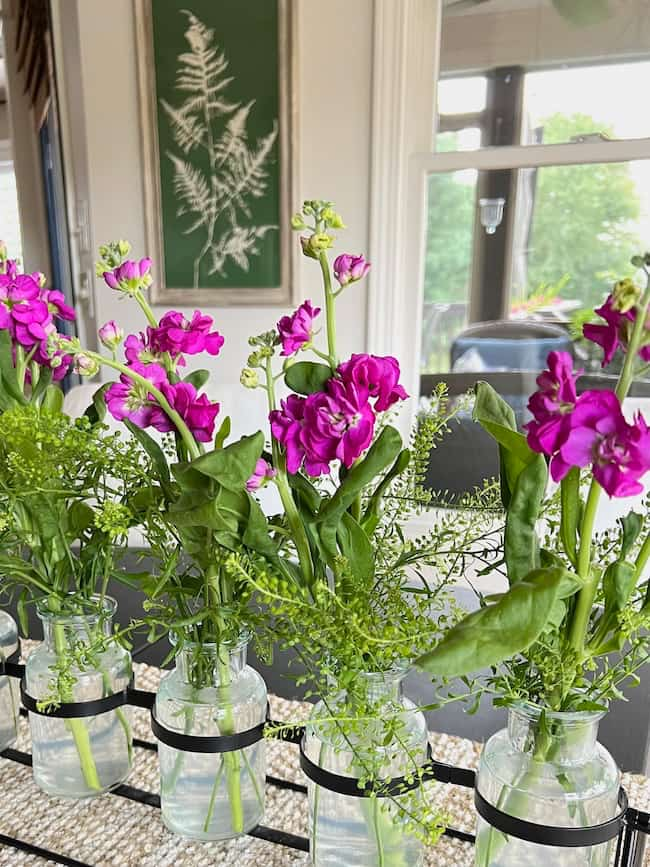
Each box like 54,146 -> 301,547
0,650 -> 650,867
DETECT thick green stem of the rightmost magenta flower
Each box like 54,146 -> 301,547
569,278 -> 650,662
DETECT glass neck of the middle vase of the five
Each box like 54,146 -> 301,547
176,635 -> 249,688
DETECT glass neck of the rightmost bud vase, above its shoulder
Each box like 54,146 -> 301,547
508,705 -> 604,765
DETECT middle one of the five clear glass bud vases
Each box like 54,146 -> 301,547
155,635 -> 267,840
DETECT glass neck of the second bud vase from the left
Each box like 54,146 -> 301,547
36,596 -> 117,650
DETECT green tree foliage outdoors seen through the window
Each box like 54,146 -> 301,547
424,114 -> 641,306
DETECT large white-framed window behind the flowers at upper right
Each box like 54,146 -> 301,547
421,0 -> 650,384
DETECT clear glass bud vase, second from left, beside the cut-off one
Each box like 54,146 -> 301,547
25,597 -> 132,798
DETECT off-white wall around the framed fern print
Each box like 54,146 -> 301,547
66,0 -> 373,418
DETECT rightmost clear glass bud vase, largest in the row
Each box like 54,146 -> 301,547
476,705 -> 620,867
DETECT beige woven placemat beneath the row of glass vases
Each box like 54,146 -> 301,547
0,664 -> 650,867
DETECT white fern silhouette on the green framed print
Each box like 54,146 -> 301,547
160,9 -> 278,289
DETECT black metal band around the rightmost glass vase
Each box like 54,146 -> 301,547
474,788 -> 628,849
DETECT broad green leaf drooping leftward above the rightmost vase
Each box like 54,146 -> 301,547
416,569 -> 563,677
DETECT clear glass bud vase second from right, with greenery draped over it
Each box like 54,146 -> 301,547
304,670 -> 427,867
